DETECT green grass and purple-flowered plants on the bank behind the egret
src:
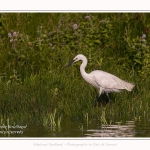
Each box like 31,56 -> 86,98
0,13 -> 150,126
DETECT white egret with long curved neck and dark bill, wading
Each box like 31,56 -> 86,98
66,54 -> 134,104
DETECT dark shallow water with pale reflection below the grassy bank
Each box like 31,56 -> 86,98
0,118 -> 150,138
